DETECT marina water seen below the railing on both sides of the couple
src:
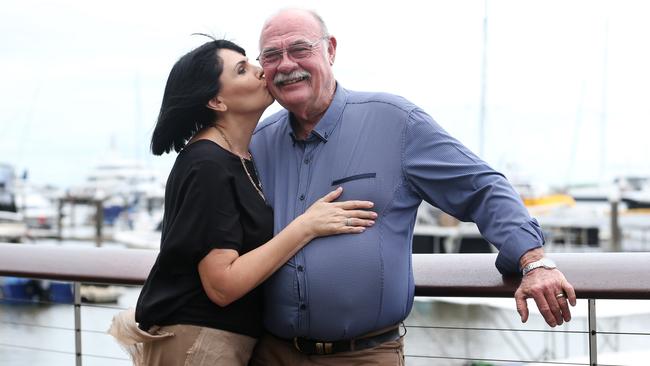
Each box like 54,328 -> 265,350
0,244 -> 650,366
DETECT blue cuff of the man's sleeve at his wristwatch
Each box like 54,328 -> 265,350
495,219 -> 544,275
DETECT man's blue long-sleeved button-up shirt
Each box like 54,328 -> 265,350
251,85 -> 544,340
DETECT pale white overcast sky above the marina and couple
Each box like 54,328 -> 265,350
0,0 -> 650,186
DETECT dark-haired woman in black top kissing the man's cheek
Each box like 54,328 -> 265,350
111,40 -> 376,365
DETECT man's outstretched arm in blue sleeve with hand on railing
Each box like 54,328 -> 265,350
403,109 -> 575,327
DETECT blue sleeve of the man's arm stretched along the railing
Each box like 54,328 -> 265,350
403,108 -> 544,274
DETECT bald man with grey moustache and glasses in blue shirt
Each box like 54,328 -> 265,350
251,9 -> 575,365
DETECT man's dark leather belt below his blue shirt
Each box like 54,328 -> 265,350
289,325 -> 400,355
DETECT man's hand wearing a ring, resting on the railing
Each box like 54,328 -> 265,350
515,268 -> 576,327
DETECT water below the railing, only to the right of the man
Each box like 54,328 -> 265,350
406,299 -> 650,365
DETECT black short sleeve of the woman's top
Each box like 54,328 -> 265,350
161,161 -> 243,268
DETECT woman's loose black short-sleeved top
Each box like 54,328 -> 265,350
136,140 -> 273,337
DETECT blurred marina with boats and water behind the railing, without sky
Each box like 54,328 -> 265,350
0,160 -> 650,366
